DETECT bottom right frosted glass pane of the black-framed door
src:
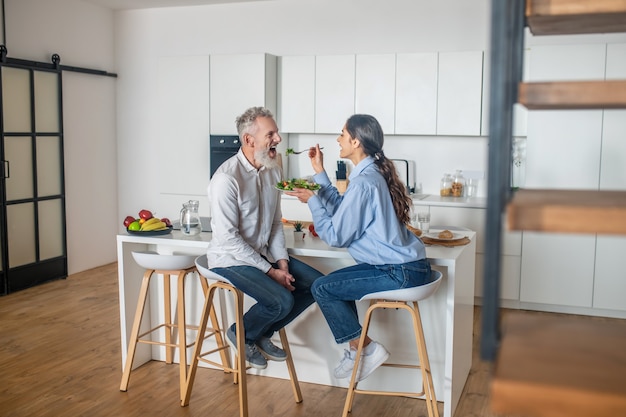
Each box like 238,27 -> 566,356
39,200 -> 64,260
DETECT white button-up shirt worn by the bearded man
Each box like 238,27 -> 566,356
207,149 -> 289,272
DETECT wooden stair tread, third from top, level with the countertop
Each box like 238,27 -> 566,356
507,189 -> 626,234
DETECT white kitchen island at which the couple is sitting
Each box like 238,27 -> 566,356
117,227 -> 476,417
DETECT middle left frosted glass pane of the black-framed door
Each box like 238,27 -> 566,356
4,136 -> 34,201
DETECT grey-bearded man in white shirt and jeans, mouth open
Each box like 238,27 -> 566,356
207,107 -> 322,369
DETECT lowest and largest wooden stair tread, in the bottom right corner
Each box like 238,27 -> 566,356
491,312 -> 626,417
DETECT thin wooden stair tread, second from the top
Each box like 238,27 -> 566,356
518,80 -> 626,110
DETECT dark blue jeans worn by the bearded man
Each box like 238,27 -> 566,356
211,257 -> 322,343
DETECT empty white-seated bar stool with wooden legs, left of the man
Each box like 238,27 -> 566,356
120,252 -> 227,399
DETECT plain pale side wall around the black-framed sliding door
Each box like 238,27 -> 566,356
5,0 -> 119,274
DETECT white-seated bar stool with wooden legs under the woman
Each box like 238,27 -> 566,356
343,270 -> 443,417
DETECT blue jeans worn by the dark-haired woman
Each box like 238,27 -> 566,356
311,259 -> 431,343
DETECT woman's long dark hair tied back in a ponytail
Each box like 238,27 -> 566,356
346,114 -> 413,224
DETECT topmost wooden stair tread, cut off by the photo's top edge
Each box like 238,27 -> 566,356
526,0 -> 626,35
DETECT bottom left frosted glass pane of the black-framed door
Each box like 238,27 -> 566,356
7,203 -> 37,268
